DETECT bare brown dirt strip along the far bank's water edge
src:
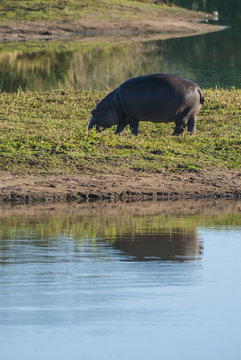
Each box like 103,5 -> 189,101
0,16 -> 222,42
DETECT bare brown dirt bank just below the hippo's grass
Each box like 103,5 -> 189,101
0,169 -> 241,203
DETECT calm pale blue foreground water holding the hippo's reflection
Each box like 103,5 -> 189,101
0,201 -> 241,360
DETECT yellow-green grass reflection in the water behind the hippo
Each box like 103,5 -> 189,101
0,41 -> 160,92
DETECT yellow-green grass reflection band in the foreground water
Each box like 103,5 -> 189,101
0,214 -> 241,241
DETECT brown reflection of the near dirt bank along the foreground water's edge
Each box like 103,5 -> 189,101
0,199 -> 241,222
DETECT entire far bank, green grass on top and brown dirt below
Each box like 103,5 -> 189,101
0,0 -> 222,42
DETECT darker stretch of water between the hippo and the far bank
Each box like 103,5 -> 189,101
0,0 -> 241,92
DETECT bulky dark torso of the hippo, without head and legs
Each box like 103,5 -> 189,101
118,74 -> 202,122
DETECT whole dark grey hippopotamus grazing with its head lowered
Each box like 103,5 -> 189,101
88,74 -> 204,135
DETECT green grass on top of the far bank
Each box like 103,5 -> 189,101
0,0 -> 203,22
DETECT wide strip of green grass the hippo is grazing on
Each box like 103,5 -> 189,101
0,89 -> 241,173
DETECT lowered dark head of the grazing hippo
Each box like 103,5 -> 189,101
88,102 -> 118,131
